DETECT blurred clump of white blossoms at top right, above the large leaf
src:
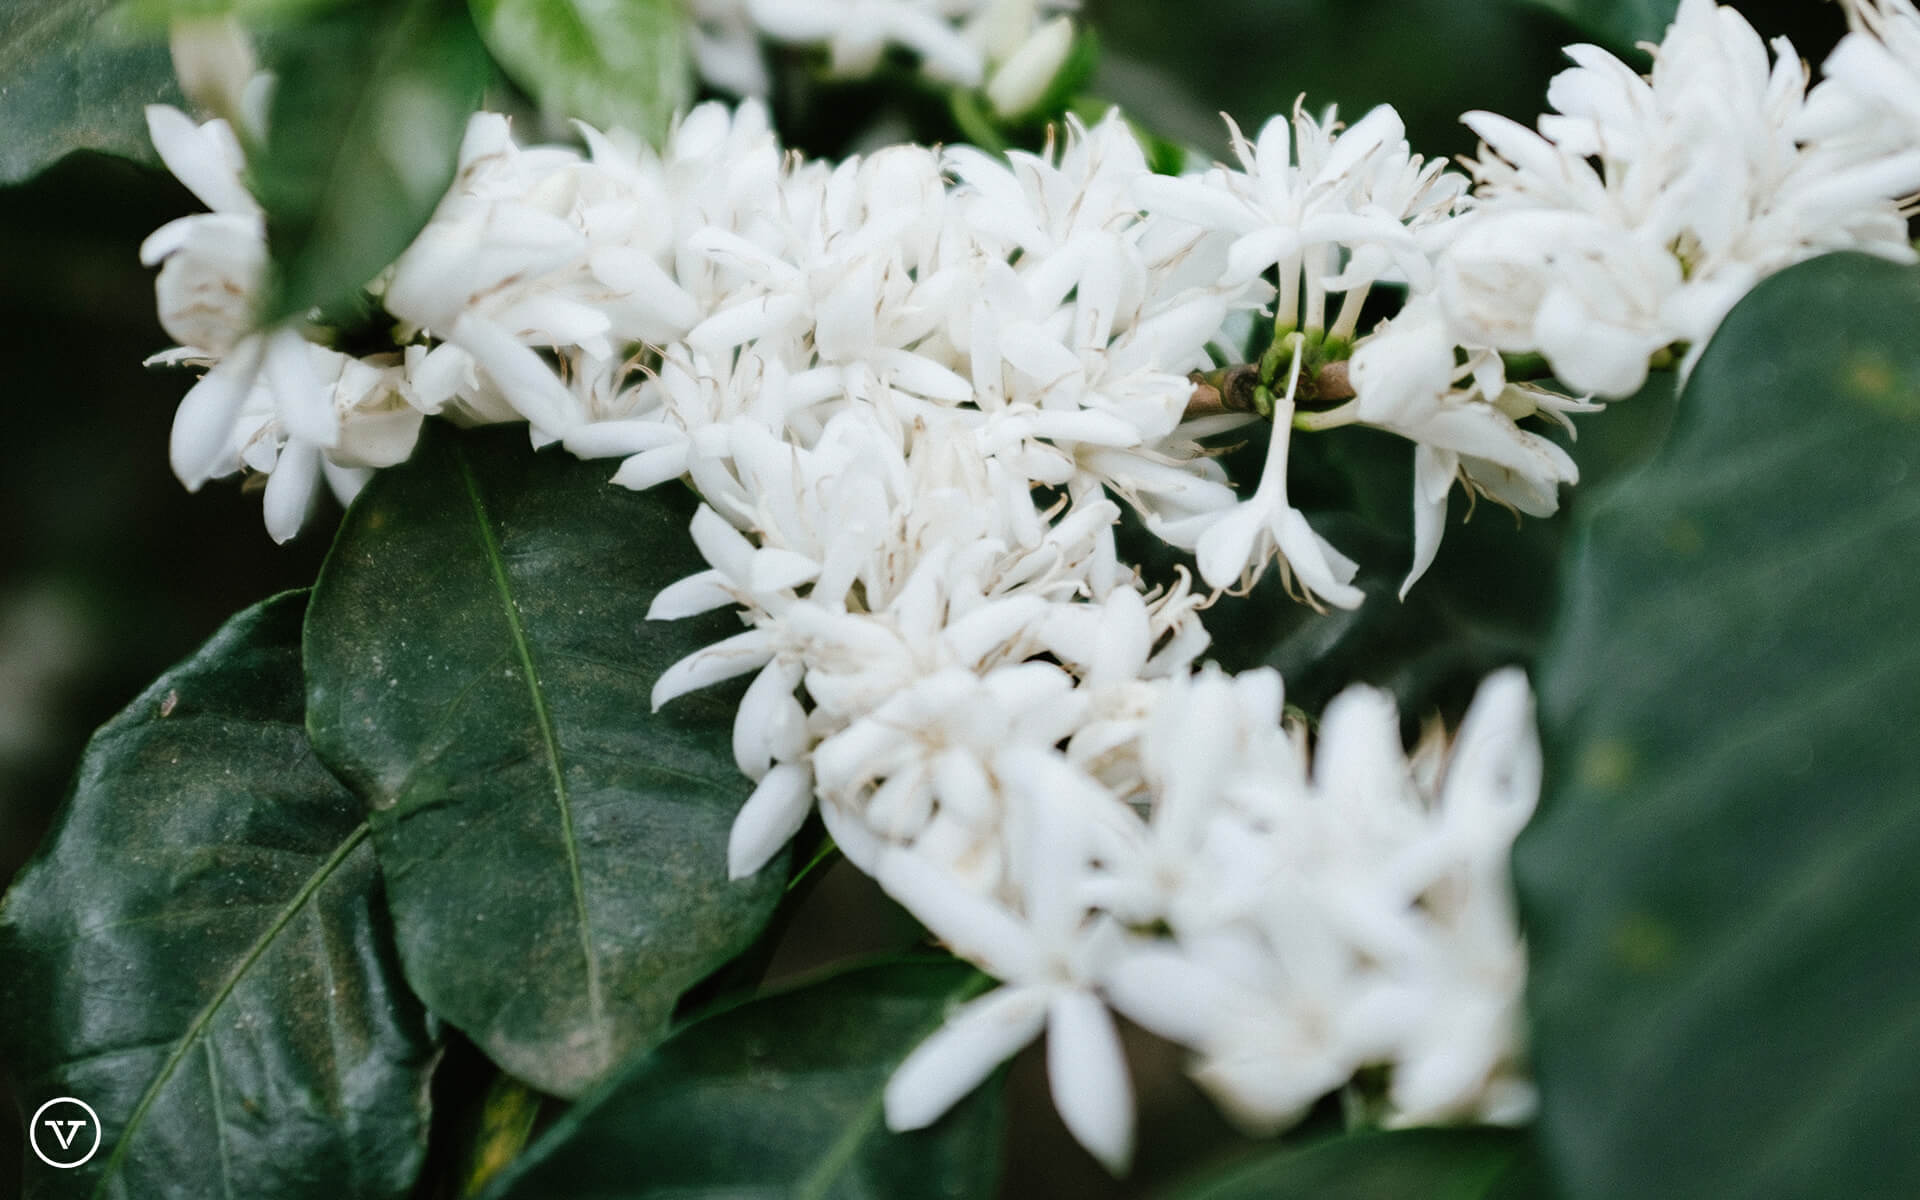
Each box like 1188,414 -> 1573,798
1438,0 -> 1920,396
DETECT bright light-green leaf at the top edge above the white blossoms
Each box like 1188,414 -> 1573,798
472,0 -> 693,140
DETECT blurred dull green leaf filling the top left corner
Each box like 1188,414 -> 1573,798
0,0 -> 182,184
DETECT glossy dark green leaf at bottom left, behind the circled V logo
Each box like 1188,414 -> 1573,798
0,593 -> 438,1200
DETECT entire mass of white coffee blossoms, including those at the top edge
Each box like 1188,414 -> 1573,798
146,0 -> 1920,1169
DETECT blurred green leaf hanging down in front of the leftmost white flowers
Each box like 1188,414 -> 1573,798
253,0 -> 488,319
